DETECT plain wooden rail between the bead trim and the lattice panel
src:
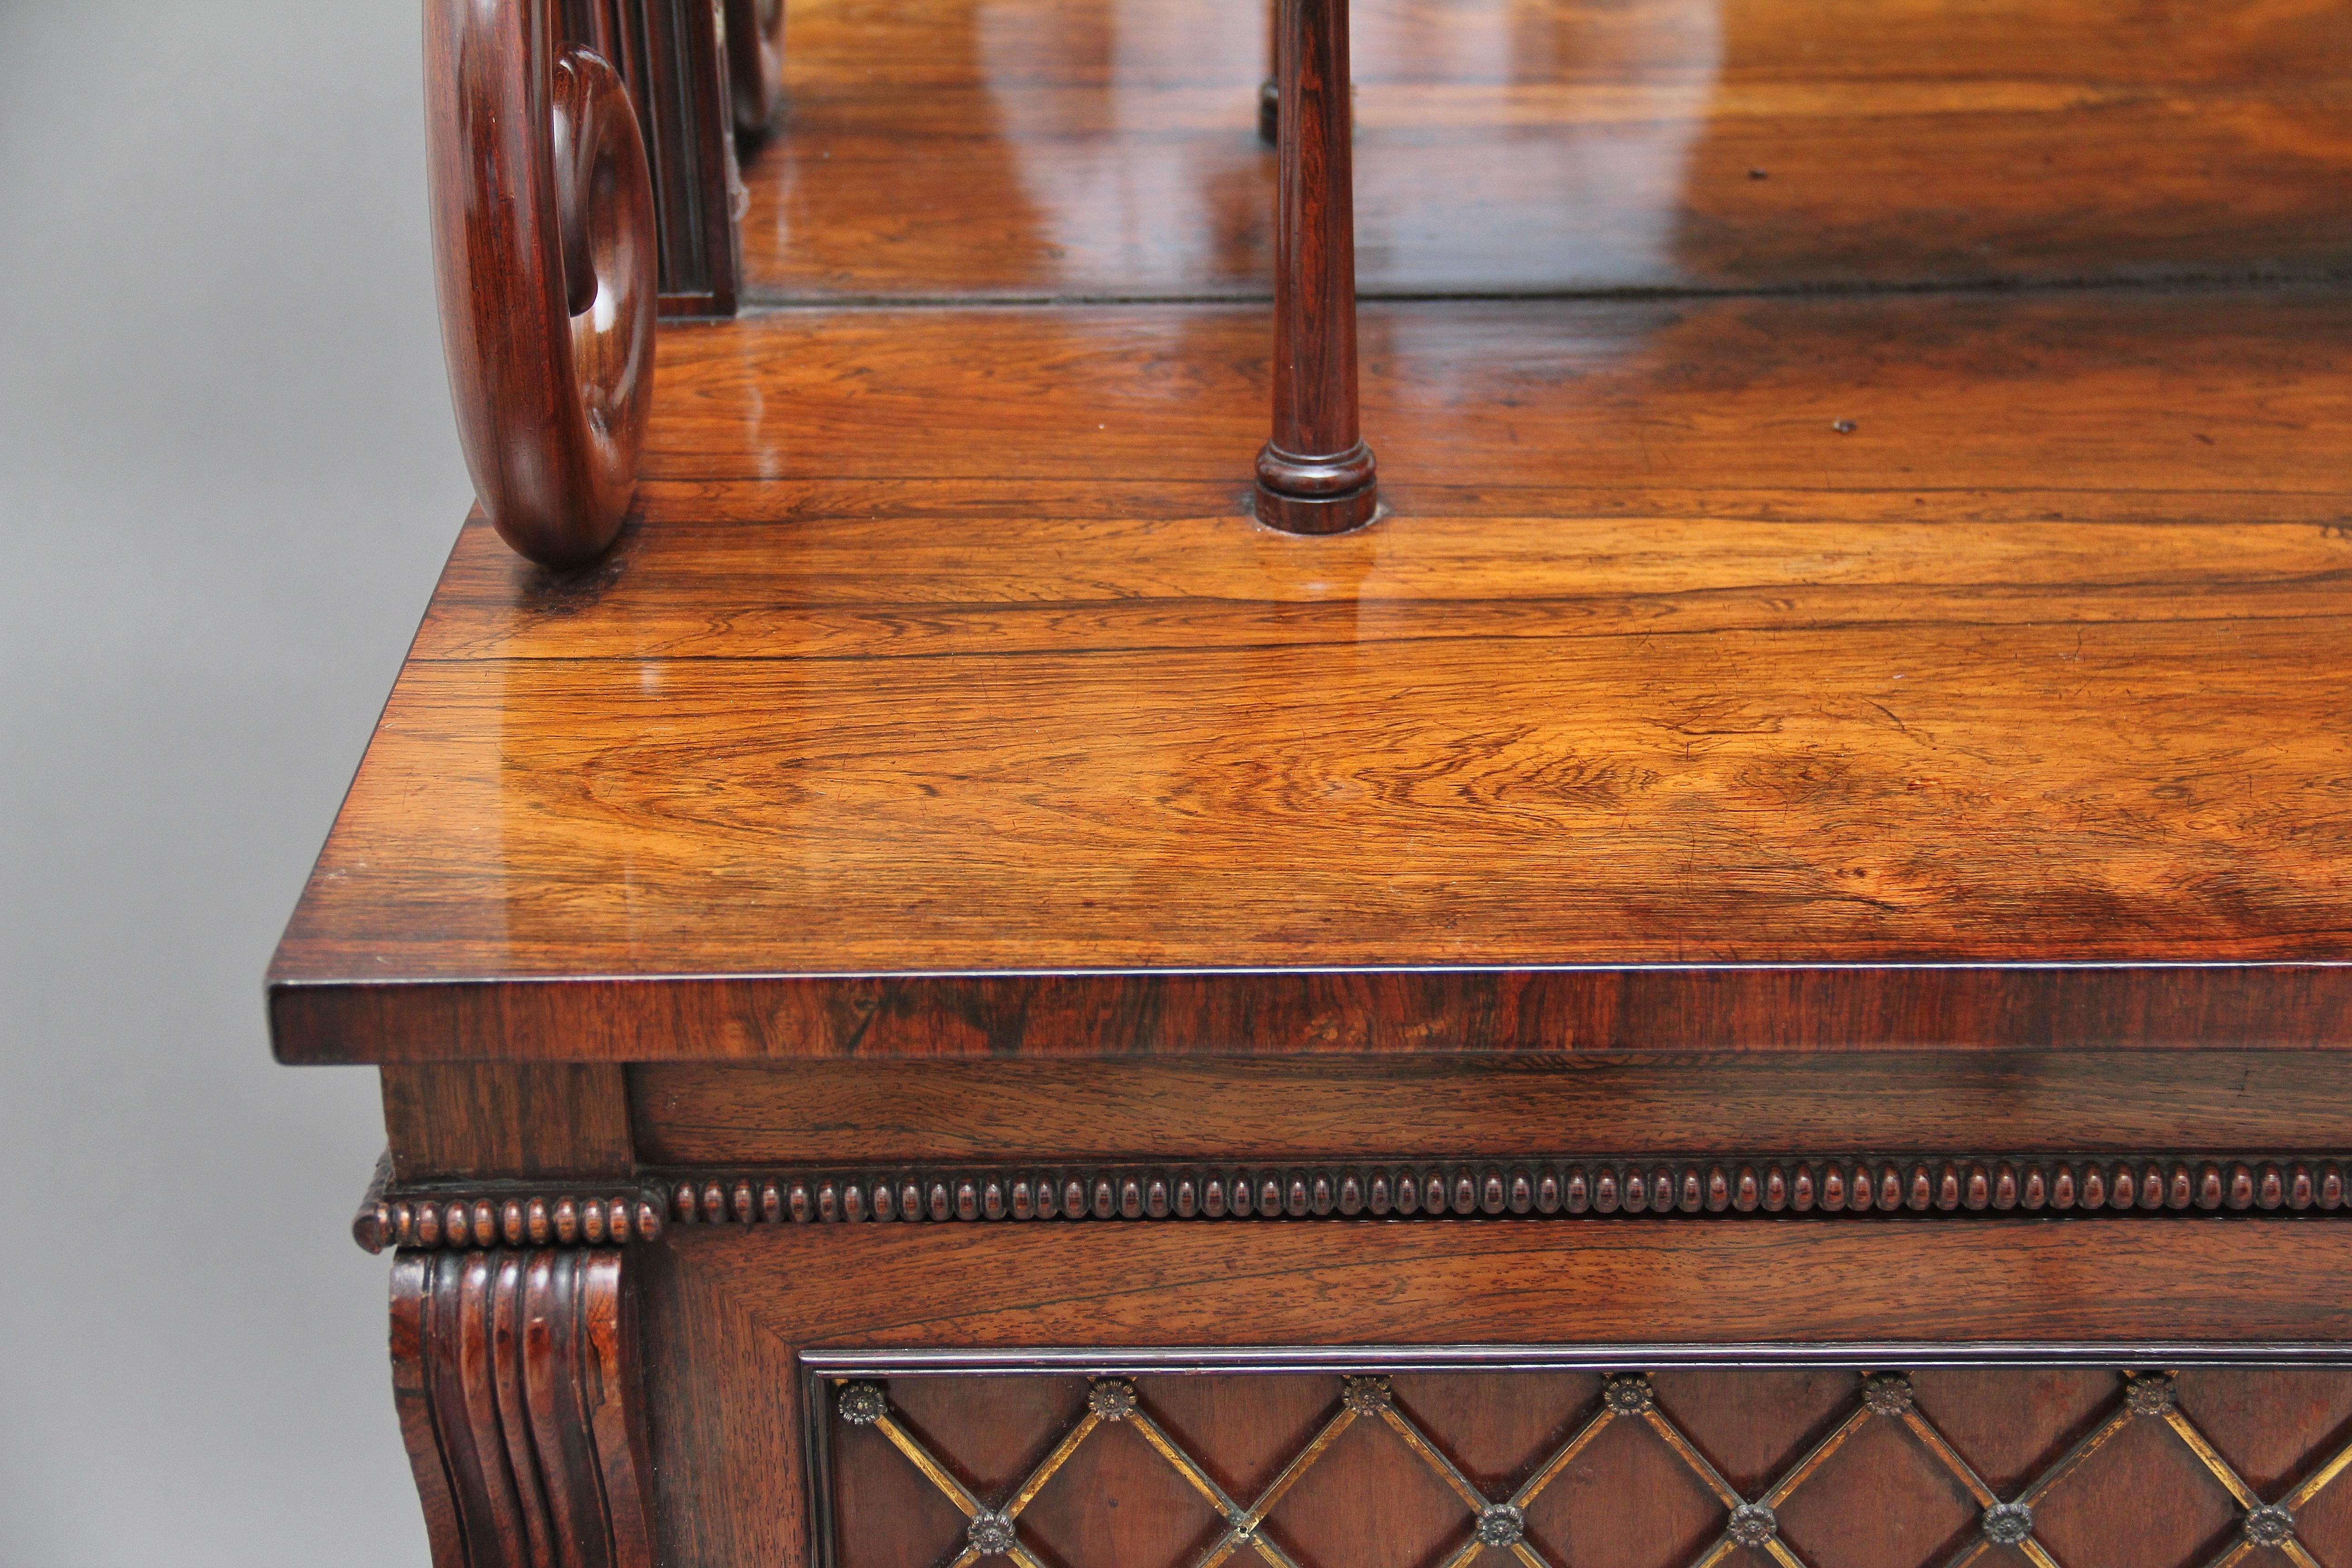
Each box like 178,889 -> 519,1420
670,1218 -> 2352,1352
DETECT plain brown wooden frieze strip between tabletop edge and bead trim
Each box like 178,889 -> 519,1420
628,1051 -> 2352,1166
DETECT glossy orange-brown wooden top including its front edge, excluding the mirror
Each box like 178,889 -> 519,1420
278,289 -> 2352,1060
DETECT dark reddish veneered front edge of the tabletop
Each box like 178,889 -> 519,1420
270,961 -> 2352,1063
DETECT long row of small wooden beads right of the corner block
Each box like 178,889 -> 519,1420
656,1154 -> 2352,1225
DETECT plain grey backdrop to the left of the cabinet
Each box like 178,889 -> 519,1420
0,0 -> 470,1568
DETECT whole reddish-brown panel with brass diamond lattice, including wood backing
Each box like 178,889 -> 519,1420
828,1366 -> 2352,1568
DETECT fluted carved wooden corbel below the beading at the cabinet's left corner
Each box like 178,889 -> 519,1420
393,1248 -> 654,1568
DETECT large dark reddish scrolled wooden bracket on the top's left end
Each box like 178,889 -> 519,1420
426,0 -> 659,567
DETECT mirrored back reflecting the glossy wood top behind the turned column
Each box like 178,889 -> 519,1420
743,0 -> 2352,299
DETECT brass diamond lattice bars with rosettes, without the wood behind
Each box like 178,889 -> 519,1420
835,1371 -> 2352,1568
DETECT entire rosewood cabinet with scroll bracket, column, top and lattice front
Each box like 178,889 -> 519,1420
268,0 -> 2352,1568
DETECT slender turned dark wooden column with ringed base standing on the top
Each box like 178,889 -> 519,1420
1258,0 -> 1381,534
